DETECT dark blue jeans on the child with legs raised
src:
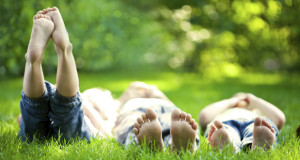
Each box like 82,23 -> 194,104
19,82 -> 90,141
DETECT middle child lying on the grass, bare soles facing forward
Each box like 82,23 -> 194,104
112,82 -> 199,152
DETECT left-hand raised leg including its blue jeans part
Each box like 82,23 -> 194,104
18,14 -> 54,141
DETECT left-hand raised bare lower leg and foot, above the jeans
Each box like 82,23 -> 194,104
23,14 -> 54,98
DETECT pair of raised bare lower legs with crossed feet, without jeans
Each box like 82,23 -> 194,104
23,7 -> 79,98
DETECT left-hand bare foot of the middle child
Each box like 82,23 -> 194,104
133,108 -> 163,149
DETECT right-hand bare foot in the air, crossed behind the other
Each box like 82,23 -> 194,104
38,7 -> 70,53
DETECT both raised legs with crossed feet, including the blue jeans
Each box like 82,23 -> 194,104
19,7 -> 90,141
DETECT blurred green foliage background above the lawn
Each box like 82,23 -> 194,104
0,0 -> 300,79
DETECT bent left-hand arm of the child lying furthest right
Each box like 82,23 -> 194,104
199,97 -> 241,130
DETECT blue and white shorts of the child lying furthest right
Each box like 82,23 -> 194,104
204,118 -> 279,150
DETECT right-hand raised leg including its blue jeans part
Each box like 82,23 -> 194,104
39,7 -> 91,140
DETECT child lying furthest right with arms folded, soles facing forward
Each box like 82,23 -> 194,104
199,93 -> 285,152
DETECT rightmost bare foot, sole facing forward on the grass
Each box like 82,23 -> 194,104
251,117 -> 275,150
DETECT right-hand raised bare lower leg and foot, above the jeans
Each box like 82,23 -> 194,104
40,7 -> 79,97
